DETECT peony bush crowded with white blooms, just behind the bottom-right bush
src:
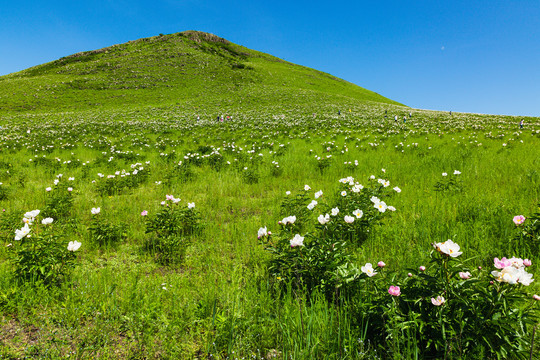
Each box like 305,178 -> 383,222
258,173 -> 395,296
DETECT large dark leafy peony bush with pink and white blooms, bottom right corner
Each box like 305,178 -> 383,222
347,240 -> 540,359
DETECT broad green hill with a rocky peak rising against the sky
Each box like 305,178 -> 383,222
0,31 -> 400,114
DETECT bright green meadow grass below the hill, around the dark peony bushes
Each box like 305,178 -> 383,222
0,107 -> 540,359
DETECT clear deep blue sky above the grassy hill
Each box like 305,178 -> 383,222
0,0 -> 540,116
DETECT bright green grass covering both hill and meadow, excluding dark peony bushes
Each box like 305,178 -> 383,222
0,34 -> 540,359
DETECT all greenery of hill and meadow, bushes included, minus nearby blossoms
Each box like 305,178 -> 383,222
0,34 -> 540,359
